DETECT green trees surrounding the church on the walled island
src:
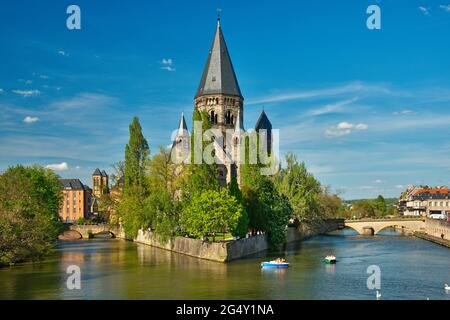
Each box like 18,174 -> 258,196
116,114 -> 343,248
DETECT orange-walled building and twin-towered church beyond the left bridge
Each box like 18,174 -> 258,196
59,169 -> 109,223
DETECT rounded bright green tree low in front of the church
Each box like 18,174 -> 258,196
183,190 -> 244,238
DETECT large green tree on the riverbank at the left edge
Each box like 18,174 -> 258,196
0,166 -> 62,265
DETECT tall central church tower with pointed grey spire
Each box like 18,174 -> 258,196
194,18 -> 244,186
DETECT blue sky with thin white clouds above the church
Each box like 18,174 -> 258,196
0,0 -> 450,199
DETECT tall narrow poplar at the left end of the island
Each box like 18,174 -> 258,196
118,117 -> 150,237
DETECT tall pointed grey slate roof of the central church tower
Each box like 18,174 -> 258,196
195,20 -> 242,98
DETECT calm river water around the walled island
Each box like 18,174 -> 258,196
0,230 -> 450,300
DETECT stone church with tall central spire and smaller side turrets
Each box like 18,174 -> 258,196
172,17 -> 272,186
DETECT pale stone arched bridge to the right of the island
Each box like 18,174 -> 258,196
345,217 -> 425,236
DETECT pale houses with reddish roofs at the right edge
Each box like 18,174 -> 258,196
398,186 -> 450,219
